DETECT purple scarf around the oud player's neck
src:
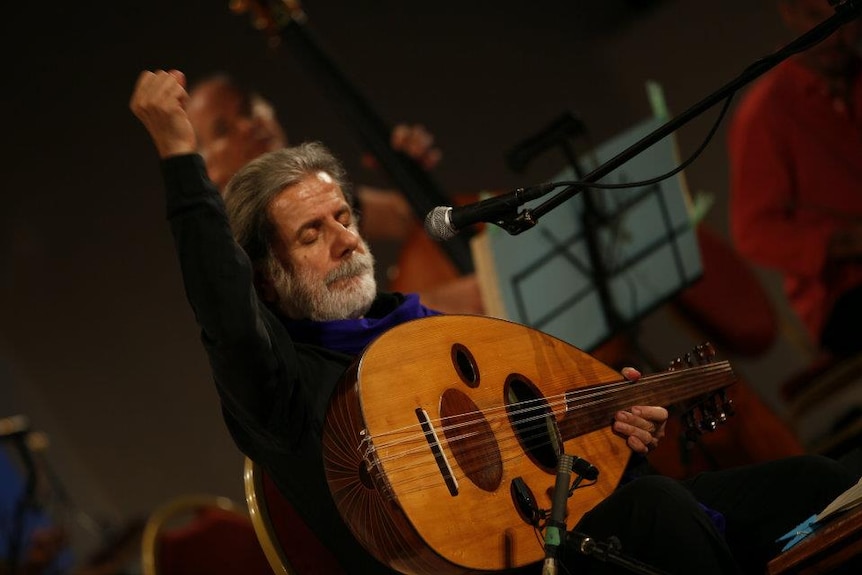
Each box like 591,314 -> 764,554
285,294 -> 440,355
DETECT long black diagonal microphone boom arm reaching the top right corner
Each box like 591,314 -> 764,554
498,0 -> 862,236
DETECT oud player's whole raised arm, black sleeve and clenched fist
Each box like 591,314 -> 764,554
130,70 -> 302,450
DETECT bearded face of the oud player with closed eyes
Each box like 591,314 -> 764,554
268,172 -> 377,321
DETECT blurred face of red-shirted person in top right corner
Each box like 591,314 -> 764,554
781,0 -> 862,78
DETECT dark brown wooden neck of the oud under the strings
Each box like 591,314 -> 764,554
559,361 -> 735,441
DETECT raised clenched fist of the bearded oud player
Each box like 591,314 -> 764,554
129,70 -> 197,158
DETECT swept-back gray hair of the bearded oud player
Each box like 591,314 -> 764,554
224,142 -> 354,264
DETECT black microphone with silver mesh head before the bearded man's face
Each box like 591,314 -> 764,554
425,183 -> 557,242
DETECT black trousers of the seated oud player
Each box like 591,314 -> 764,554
558,455 -> 858,575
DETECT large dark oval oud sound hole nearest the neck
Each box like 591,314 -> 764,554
504,374 -> 563,473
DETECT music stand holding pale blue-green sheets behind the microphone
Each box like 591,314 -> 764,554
471,118 -> 703,351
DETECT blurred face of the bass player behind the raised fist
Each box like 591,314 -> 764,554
188,79 -> 287,189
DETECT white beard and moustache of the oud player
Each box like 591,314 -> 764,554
270,245 -> 377,321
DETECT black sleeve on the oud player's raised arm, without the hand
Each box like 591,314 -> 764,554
162,154 -> 306,451
